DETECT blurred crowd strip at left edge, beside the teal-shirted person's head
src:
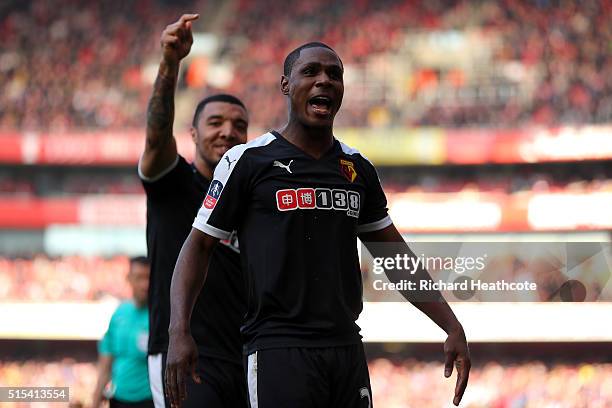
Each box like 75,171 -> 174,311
0,254 -> 130,302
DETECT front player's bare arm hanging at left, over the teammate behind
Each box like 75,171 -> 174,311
166,228 -> 219,407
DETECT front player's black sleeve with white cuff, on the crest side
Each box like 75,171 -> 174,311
357,158 -> 392,233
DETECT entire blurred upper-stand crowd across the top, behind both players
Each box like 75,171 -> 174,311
0,0 -> 612,130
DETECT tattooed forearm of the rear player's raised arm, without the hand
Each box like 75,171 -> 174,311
147,62 -> 178,149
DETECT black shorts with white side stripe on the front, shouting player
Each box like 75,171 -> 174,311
245,343 -> 373,408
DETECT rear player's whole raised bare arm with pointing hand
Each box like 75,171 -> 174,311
139,14 -> 199,178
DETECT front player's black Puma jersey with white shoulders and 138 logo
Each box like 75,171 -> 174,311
193,132 -> 391,354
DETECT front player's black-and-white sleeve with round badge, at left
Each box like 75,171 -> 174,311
193,145 -> 250,239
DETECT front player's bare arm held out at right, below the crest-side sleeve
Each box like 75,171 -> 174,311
359,224 -> 471,405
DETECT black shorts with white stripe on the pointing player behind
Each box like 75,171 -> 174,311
149,353 -> 248,408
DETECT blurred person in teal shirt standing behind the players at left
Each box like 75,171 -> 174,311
92,257 -> 153,408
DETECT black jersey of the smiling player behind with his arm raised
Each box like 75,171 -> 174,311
140,156 -> 246,364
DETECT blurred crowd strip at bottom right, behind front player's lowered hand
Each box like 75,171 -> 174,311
369,359 -> 612,408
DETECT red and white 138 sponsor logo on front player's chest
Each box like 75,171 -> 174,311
276,188 -> 361,218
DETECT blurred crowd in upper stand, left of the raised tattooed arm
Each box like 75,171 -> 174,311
0,0 -> 181,130
